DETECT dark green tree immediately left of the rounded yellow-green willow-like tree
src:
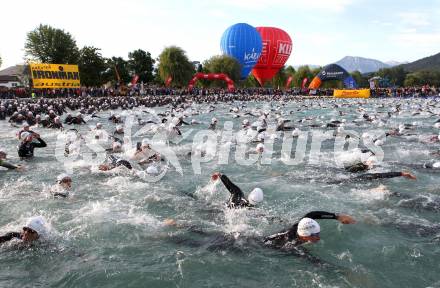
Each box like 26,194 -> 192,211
128,49 -> 155,83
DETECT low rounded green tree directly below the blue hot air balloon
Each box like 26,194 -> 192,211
202,55 -> 241,87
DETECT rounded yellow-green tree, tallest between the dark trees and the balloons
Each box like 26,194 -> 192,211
158,46 -> 195,87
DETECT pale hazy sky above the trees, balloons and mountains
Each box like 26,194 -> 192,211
0,0 -> 440,68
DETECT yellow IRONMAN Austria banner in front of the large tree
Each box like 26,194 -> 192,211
30,64 -> 81,89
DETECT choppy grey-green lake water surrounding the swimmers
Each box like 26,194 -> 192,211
0,99 -> 440,287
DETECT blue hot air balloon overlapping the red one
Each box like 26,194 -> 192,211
220,23 -> 263,79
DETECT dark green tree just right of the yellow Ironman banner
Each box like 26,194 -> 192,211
78,46 -> 107,87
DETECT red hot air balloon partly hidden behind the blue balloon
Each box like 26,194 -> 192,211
252,27 -> 292,86
